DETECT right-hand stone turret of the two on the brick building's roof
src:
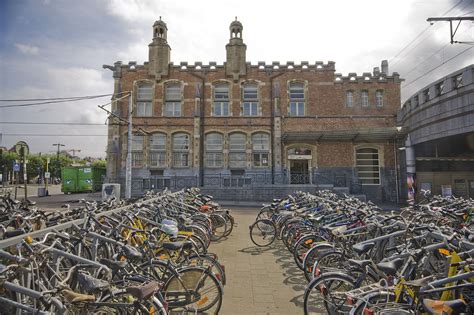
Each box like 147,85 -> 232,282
225,17 -> 247,81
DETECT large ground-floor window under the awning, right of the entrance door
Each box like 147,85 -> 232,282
356,148 -> 380,185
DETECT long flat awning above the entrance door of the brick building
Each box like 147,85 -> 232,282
281,127 -> 404,142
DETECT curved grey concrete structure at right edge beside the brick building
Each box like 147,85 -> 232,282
398,65 -> 474,198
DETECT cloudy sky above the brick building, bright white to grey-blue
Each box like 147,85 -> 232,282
0,0 -> 474,157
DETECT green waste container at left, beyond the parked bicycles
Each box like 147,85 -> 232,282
61,166 -> 105,193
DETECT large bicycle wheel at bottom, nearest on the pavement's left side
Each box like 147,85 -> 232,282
163,266 -> 223,314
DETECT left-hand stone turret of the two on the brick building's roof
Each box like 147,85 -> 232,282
148,16 -> 171,81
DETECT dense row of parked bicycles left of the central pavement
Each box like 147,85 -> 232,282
0,188 -> 234,315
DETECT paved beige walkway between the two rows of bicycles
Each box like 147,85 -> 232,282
209,208 -> 307,315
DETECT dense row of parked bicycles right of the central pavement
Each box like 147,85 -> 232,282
249,191 -> 474,315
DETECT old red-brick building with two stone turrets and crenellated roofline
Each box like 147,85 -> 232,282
104,19 -> 401,201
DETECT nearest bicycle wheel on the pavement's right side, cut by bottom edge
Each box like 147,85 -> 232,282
304,273 -> 356,315
